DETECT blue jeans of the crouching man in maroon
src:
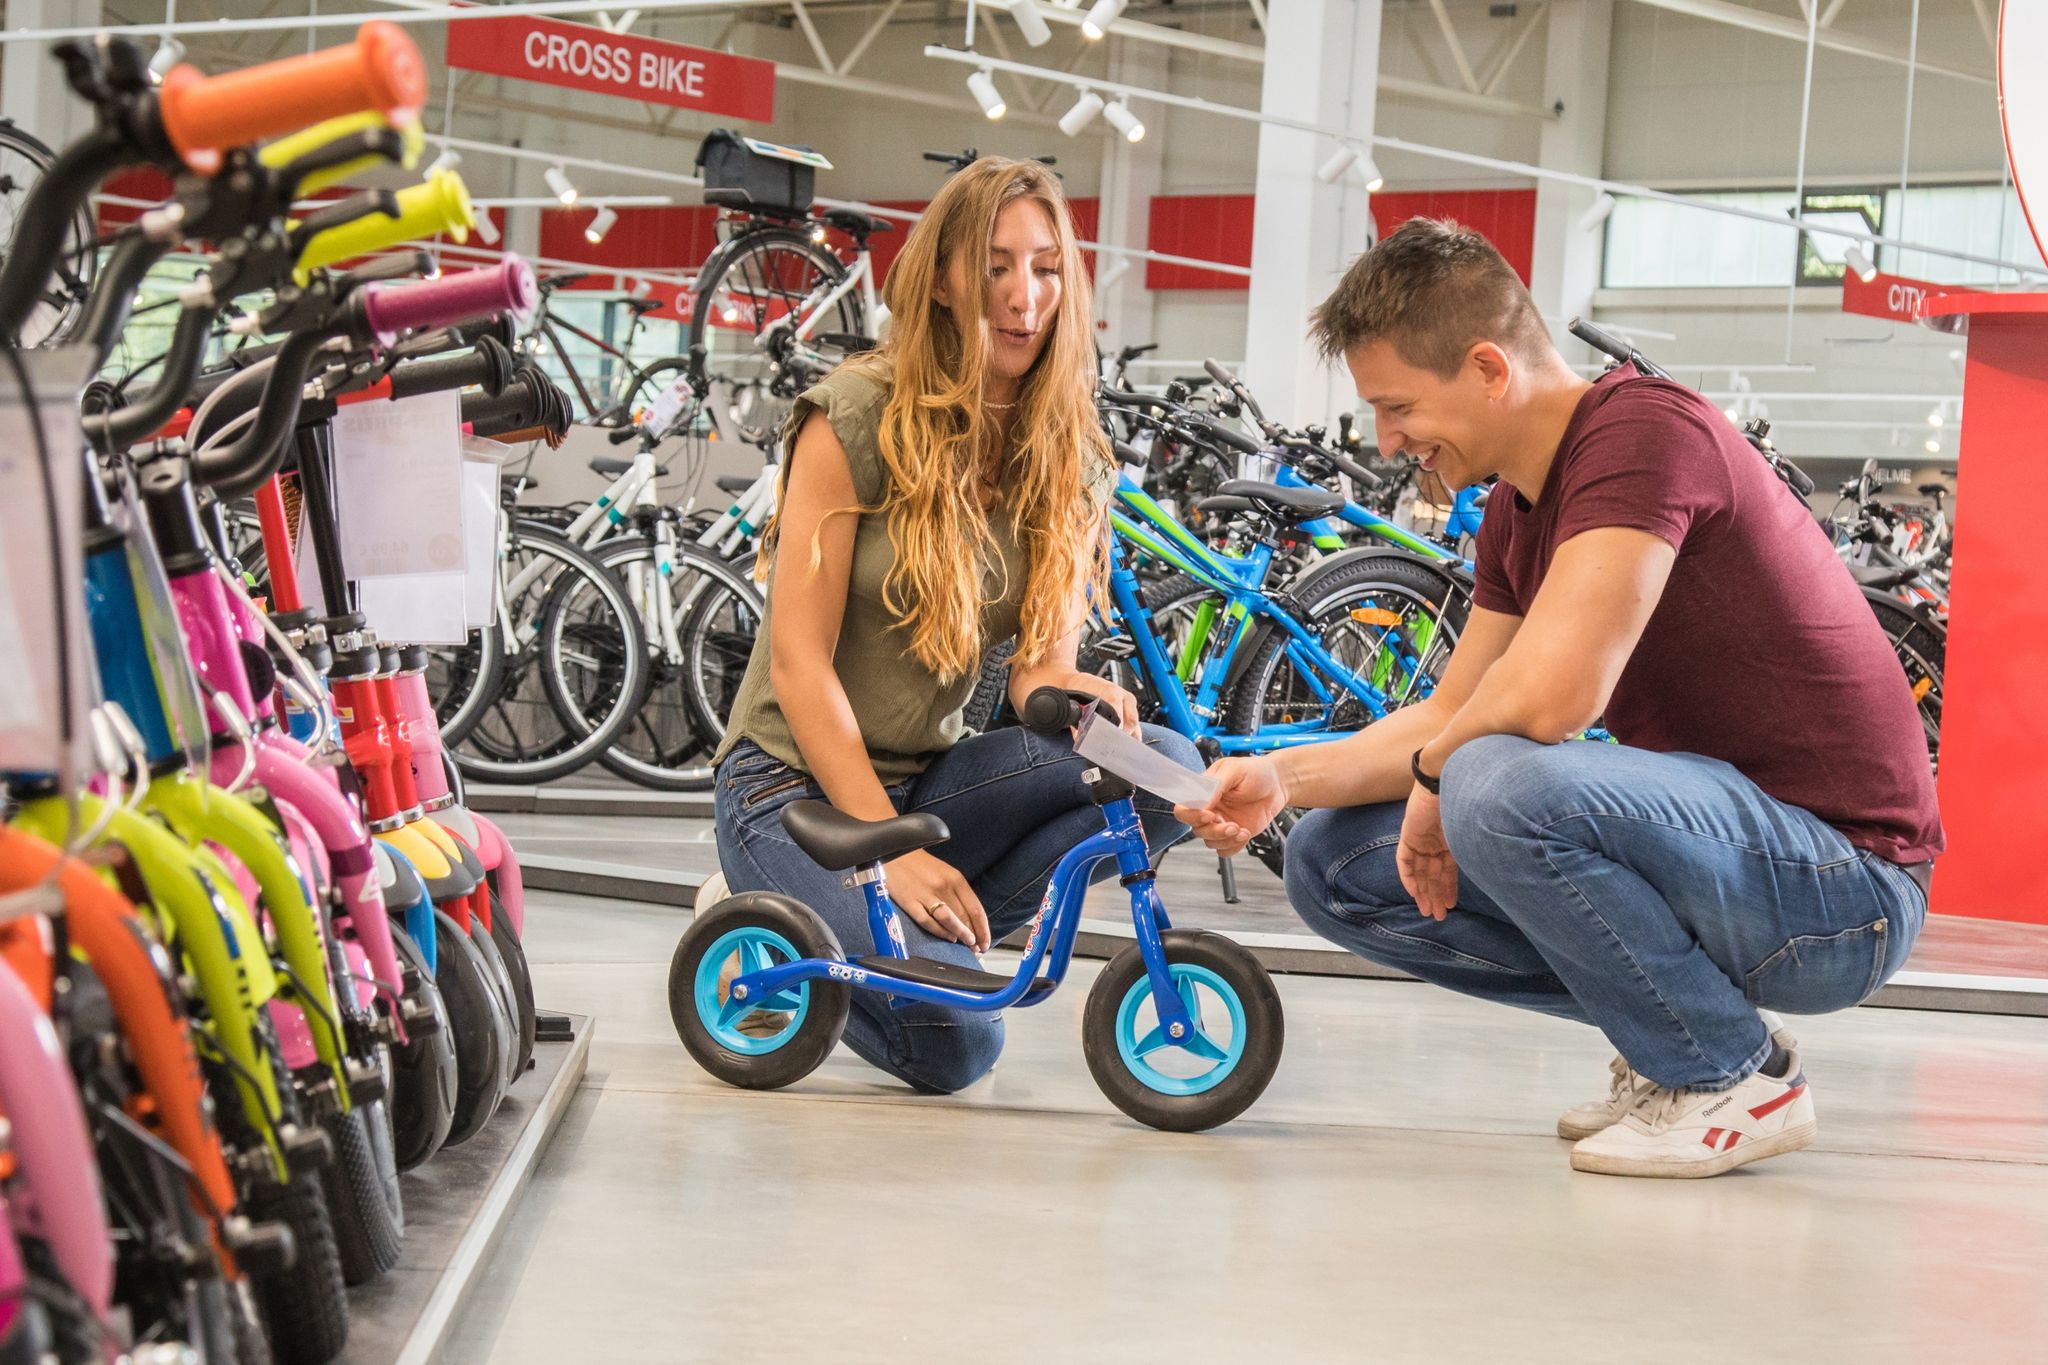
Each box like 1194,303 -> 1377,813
1286,735 -> 1927,1091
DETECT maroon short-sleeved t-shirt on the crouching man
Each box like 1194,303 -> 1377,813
1477,366 -> 1944,864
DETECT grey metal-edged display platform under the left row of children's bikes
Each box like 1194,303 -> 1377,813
338,1011 -> 594,1365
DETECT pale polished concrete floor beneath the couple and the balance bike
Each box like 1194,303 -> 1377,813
442,879 -> 2048,1365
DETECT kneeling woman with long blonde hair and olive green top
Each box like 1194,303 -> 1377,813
717,158 -> 1200,1091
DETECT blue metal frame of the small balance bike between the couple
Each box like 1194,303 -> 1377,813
725,788 -> 1194,1038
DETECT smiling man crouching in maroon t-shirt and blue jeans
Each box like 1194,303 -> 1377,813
1176,219 -> 1942,1177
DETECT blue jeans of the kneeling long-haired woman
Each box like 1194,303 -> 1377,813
713,724 -> 1202,1091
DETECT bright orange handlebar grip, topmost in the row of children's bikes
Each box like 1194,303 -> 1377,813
158,18 -> 426,172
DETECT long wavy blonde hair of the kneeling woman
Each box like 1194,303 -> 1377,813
764,156 -> 1114,679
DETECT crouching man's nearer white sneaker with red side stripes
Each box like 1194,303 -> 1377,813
1571,1052 -> 1819,1179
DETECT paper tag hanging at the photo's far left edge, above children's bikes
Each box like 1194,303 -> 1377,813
0,346 -> 94,774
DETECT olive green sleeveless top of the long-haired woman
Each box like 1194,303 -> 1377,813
713,366 -> 1116,784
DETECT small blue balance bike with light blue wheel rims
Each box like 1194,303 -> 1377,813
668,688 -> 1286,1132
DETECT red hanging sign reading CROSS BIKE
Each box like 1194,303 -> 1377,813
449,18 -> 774,123
